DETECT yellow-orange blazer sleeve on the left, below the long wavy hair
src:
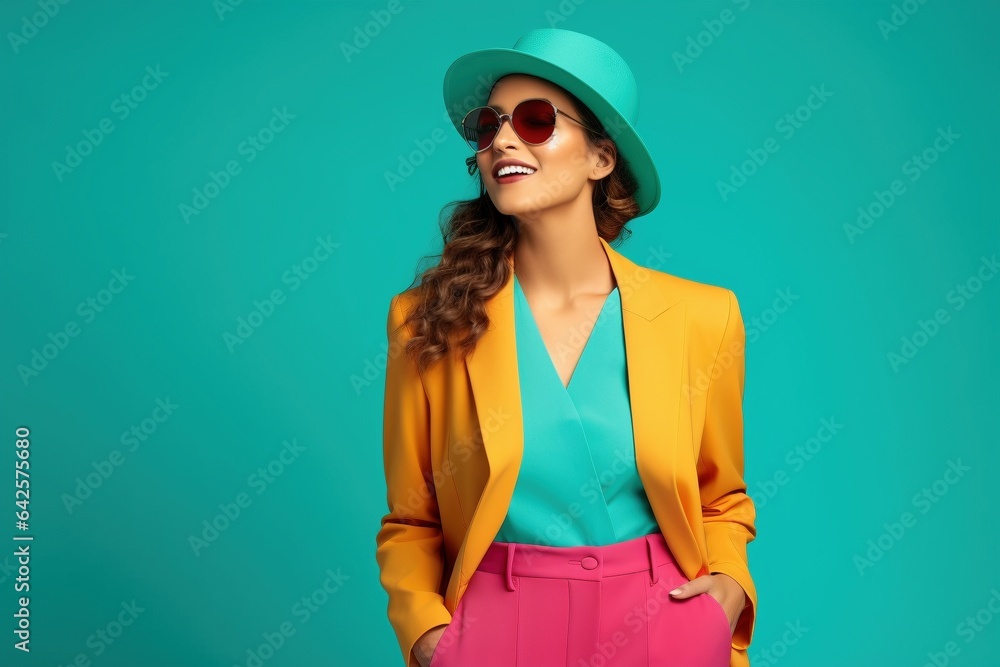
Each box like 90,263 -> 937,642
375,295 -> 451,667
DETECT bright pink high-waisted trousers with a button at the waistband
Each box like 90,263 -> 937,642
430,533 -> 732,667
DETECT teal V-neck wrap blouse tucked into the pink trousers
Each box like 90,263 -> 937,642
495,275 -> 660,546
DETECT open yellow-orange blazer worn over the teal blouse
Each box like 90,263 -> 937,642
376,239 -> 757,667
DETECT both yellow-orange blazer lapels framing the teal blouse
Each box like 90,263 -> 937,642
446,238 -> 701,609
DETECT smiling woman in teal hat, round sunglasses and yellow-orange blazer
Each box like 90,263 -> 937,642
376,29 -> 756,667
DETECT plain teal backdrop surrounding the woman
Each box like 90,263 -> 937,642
0,0 -> 1000,667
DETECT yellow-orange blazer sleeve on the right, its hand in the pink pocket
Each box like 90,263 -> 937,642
698,290 -> 757,649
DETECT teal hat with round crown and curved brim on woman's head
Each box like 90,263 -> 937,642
444,28 -> 660,217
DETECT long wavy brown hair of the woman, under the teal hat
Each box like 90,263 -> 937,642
403,84 -> 639,370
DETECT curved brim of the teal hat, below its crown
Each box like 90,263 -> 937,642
444,49 -> 660,217
